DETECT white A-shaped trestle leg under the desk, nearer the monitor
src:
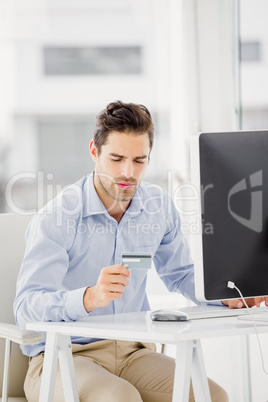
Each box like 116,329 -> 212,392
172,340 -> 211,402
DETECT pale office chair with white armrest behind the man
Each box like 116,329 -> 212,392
0,214 -> 43,402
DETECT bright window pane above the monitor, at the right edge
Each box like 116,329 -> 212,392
240,0 -> 268,130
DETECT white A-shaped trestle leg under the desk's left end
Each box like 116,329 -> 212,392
39,332 -> 79,402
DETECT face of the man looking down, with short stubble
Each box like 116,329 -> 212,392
90,131 -> 150,205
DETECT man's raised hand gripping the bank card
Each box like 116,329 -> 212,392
83,264 -> 131,313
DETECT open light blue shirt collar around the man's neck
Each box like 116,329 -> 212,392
83,172 -> 144,218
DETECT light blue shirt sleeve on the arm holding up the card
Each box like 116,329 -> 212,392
14,213 -> 87,329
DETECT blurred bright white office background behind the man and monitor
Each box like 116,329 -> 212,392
0,0 -> 268,402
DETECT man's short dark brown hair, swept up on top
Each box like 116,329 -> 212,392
94,101 -> 154,153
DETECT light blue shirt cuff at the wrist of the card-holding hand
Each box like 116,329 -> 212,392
65,287 -> 88,321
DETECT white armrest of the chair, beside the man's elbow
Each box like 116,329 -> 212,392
0,323 -> 43,345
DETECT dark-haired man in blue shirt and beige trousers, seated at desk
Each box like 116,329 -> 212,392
14,101 -> 260,402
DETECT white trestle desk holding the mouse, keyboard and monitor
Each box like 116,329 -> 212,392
27,312 -> 268,402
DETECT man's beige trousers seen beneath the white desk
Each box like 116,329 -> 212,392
24,340 -> 228,402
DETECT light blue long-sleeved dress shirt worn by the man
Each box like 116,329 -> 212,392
14,174 -> 197,356
